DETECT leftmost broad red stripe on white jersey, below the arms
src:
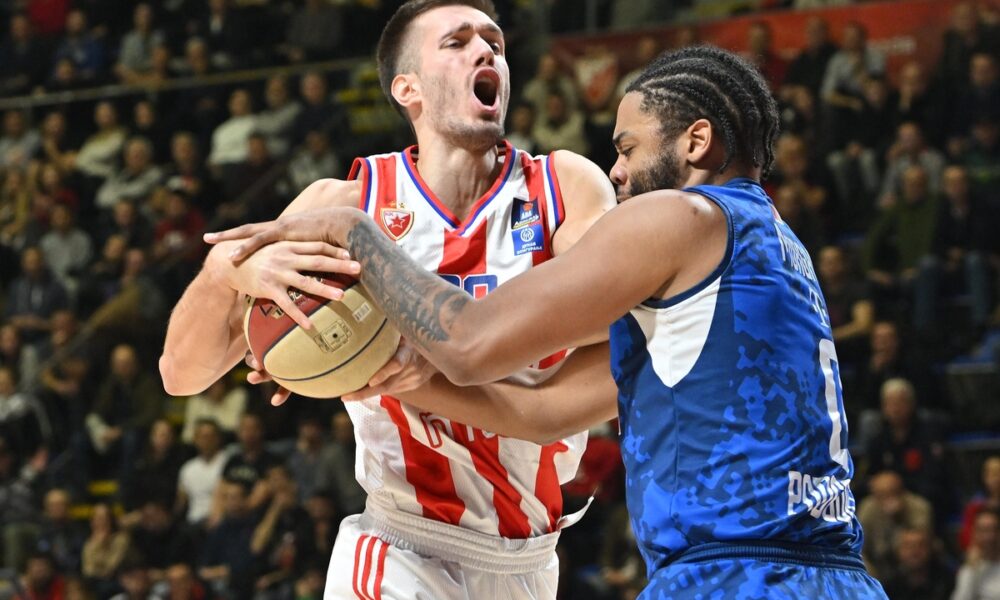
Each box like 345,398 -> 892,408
382,396 -> 465,525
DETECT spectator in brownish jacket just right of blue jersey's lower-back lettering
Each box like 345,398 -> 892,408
858,471 -> 933,577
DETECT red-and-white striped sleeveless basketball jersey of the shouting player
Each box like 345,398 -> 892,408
347,142 -> 587,538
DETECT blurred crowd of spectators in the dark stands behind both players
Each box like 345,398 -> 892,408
0,0 -> 1000,600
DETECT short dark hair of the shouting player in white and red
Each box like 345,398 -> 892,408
375,0 -> 497,122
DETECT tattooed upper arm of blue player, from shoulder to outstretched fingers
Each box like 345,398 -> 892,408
210,191 -> 728,385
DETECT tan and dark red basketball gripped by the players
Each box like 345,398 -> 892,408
243,275 -> 399,398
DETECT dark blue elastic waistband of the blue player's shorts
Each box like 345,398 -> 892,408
663,540 -> 866,571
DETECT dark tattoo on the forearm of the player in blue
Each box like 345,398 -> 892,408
347,219 -> 472,349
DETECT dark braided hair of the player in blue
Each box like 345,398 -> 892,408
626,46 -> 779,177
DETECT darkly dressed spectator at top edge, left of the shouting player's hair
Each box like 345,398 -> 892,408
283,0 -> 344,63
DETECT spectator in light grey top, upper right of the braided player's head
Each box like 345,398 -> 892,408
820,22 -> 885,144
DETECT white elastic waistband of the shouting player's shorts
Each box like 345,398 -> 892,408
360,496 -> 559,575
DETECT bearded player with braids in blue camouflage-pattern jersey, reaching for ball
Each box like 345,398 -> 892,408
207,47 -> 885,599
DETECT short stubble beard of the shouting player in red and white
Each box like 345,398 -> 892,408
427,77 -> 506,149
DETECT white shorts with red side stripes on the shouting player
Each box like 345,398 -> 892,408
323,499 -> 559,600
